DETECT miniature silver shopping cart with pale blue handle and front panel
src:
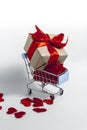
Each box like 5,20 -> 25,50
22,53 -> 68,100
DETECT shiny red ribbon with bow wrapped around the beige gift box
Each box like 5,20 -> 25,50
27,26 -> 68,68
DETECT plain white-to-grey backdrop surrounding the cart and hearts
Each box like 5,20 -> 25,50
0,0 -> 87,130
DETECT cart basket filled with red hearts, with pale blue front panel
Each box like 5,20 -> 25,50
33,65 -> 69,85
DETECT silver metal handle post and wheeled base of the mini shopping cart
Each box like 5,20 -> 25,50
22,53 -> 64,100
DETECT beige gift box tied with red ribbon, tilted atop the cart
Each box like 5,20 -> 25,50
24,26 -> 68,69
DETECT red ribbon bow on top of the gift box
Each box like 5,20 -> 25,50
31,25 -> 68,48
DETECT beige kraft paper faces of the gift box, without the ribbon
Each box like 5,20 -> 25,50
24,34 -> 68,69
